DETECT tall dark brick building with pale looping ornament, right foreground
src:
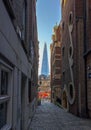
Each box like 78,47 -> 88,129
61,0 -> 91,117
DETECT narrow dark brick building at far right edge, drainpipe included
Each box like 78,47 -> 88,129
84,0 -> 91,117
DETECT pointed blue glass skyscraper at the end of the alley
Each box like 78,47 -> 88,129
41,43 -> 49,76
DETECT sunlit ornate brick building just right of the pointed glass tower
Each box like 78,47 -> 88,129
50,24 -> 61,103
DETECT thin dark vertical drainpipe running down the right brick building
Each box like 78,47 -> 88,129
83,0 -> 88,117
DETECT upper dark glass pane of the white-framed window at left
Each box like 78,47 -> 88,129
1,70 -> 8,95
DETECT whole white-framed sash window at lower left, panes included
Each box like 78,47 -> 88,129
0,63 -> 12,129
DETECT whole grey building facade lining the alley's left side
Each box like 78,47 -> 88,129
0,0 -> 39,130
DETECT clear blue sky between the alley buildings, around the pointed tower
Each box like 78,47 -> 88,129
36,0 -> 61,74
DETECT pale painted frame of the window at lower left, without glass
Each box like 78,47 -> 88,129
0,59 -> 13,130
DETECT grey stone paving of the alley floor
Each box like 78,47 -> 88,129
29,102 -> 91,130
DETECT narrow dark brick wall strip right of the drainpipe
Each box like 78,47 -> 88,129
85,0 -> 91,117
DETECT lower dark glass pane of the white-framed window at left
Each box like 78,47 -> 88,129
0,103 -> 7,129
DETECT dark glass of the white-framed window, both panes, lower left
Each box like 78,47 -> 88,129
0,70 -> 8,129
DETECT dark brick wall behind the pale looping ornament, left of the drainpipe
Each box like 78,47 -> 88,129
62,0 -> 86,116
